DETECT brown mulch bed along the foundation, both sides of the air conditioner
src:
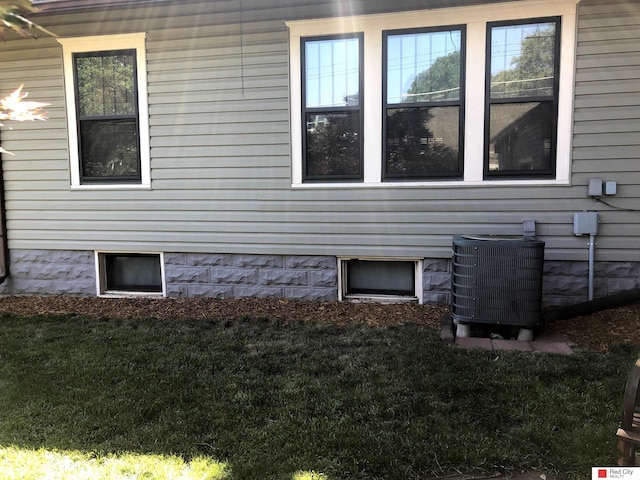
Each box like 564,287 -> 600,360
0,296 -> 640,351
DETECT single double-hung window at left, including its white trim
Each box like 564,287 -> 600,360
60,34 -> 150,188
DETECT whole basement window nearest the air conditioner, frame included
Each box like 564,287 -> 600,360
338,258 -> 422,303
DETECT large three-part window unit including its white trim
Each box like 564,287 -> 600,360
287,0 -> 577,188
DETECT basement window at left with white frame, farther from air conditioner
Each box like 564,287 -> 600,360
96,252 -> 166,297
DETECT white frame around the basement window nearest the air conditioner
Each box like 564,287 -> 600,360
337,256 -> 424,305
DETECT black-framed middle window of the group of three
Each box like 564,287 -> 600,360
383,27 -> 465,180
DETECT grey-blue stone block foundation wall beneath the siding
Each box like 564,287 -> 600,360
0,250 -> 640,307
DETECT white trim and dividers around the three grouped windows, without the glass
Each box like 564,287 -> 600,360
286,0 -> 579,188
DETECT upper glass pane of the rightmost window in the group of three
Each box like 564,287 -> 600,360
491,23 -> 556,98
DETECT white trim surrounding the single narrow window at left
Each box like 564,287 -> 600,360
57,33 -> 151,190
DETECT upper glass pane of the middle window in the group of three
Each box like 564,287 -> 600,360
386,30 -> 461,104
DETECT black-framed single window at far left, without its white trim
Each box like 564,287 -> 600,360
73,50 -> 141,183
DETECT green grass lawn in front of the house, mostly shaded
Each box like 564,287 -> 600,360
0,316 -> 640,480
